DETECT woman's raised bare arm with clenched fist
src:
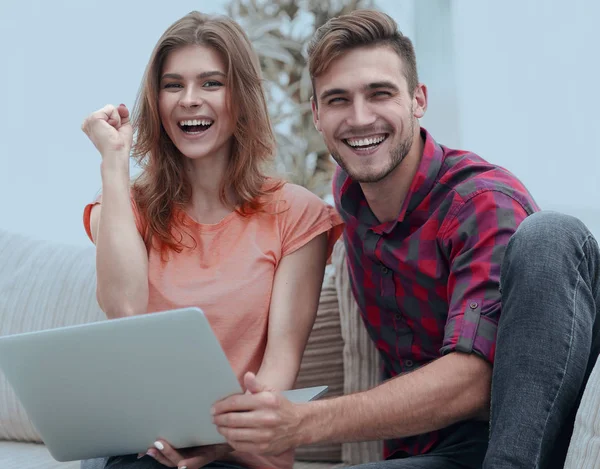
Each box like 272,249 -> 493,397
83,105 -> 148,318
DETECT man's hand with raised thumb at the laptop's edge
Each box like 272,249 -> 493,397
211,373 -> 302,454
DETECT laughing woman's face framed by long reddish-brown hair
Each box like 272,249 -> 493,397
158,45 -> 235,159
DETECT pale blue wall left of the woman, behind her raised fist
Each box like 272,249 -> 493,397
0,0 -> 230,244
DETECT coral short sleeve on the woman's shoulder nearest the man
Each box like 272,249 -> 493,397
277,183 -> 343,258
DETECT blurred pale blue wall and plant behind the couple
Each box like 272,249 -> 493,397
0,0 -> 600,244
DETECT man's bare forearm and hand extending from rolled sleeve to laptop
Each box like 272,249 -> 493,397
214,352 -> 492,454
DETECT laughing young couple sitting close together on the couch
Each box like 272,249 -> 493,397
82,10 -> 600,469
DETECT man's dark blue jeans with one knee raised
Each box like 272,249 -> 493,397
350,212 -> 600,469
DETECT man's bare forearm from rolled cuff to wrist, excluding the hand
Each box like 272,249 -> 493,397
298,352 -> 492,444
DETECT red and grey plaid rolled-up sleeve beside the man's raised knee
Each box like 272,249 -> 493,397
440,191 -> 528,363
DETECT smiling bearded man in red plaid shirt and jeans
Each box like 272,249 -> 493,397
214,10 -> 600,469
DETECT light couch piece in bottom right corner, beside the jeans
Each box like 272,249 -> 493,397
564,354 -> 600,469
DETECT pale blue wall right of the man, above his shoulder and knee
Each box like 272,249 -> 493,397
452,0 -> 600,239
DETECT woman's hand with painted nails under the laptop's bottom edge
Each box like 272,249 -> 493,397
138,440 -> 233,469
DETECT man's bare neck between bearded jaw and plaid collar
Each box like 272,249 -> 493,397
360,132 -> 424,223
